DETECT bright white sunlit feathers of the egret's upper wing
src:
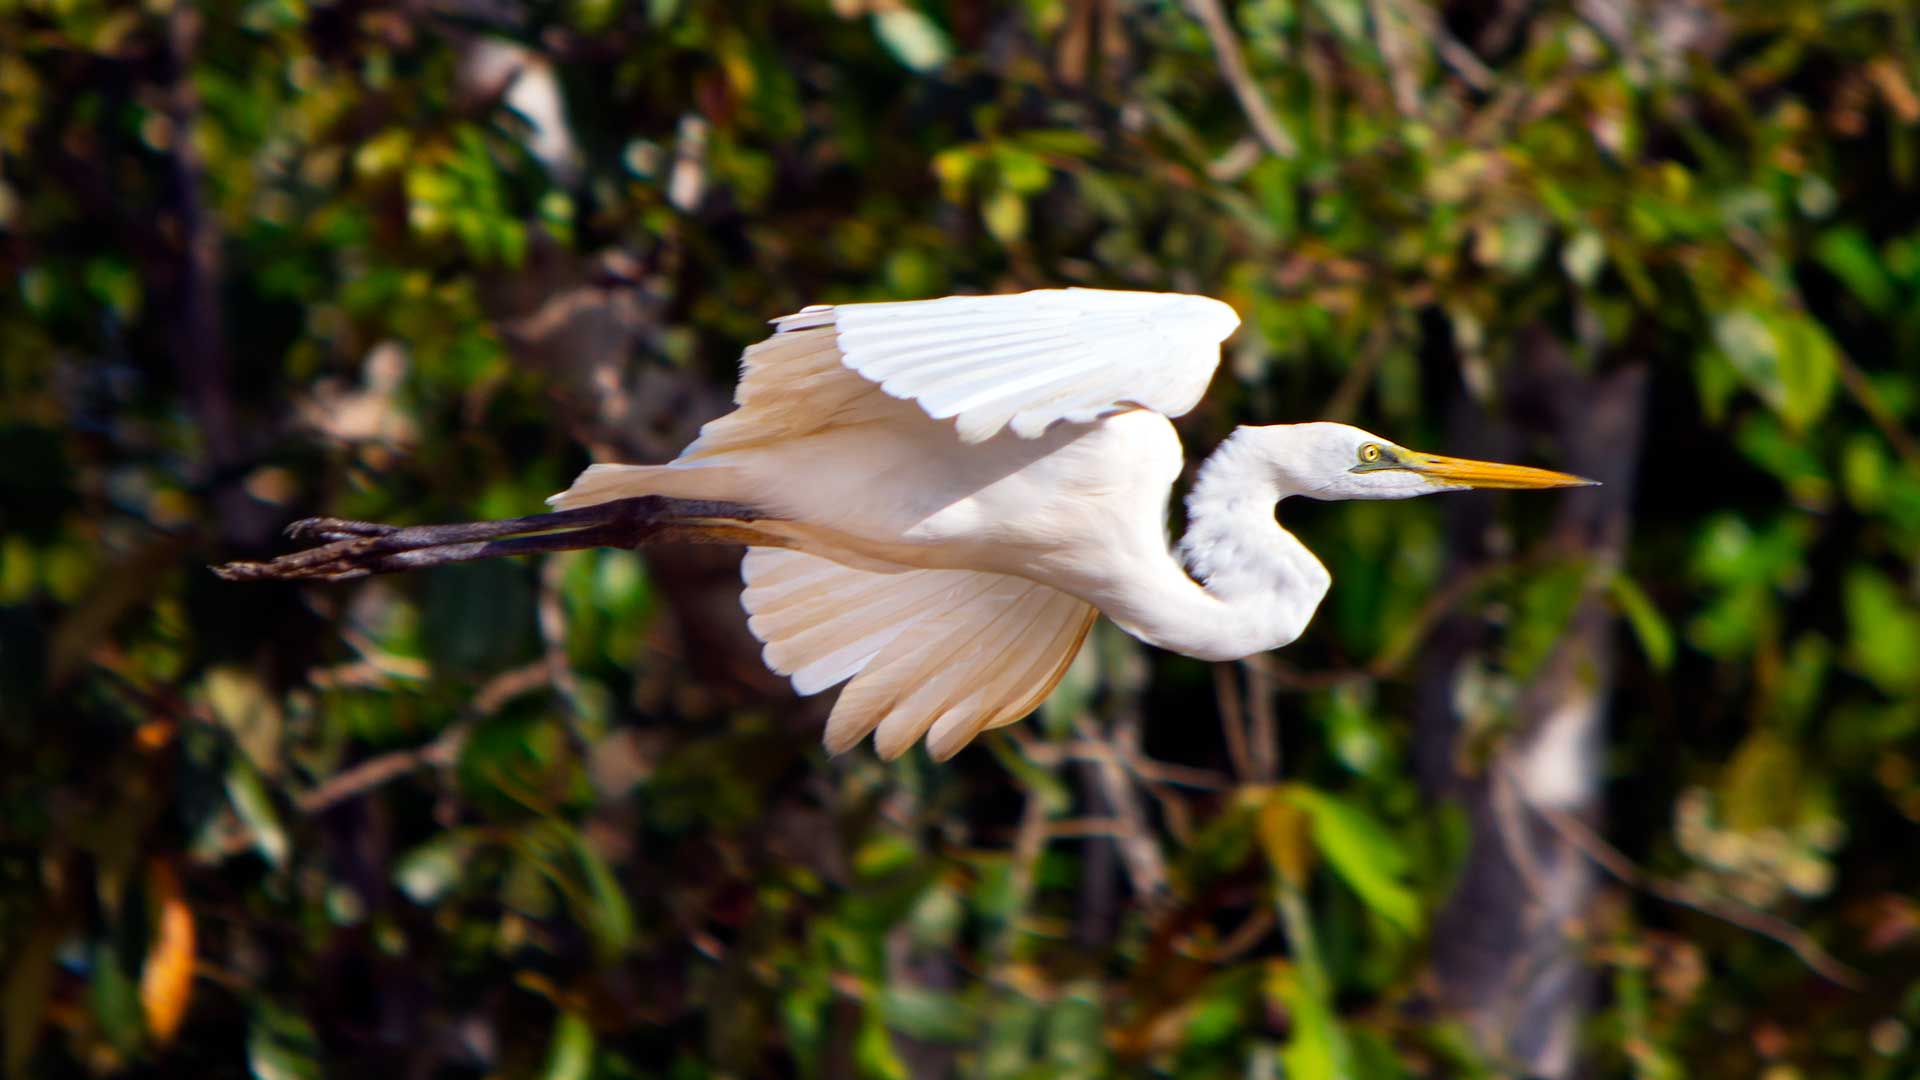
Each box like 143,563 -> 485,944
774,288 -> 1240,442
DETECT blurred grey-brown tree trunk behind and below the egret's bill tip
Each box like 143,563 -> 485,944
1415,329 -> 1645,1080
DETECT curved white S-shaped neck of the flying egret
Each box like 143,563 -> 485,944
1100,429 -> 1332,661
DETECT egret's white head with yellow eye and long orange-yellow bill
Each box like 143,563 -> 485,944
1252,423 -> 1597,500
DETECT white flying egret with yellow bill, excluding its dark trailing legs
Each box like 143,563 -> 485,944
547,288 -> 1592,759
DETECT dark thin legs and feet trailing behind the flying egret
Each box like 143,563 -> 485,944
213,496 -> 778,580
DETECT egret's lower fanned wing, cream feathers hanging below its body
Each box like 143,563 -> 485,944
741,548 -> 1096,759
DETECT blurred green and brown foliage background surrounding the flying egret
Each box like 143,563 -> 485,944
0,0 -> 1920,1080
